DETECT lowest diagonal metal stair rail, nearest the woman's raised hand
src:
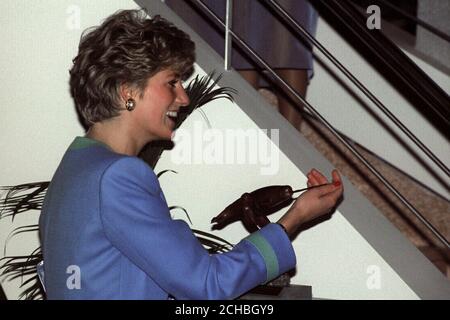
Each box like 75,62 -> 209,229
191,0 -> 450,248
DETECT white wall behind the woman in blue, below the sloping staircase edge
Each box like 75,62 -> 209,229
0,0 -> 424,299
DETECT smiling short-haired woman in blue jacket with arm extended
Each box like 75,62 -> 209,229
40,10 -> 342,299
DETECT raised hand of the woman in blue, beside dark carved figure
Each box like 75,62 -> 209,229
278,169 -> 344,235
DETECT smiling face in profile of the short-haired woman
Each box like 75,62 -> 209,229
132,70 -> 189,141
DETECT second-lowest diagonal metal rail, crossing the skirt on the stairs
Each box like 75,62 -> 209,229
261,0 -> 450,176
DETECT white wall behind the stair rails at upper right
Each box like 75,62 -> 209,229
308,19 -> 450,199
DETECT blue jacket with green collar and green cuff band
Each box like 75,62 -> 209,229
39,137 -> 296,299
